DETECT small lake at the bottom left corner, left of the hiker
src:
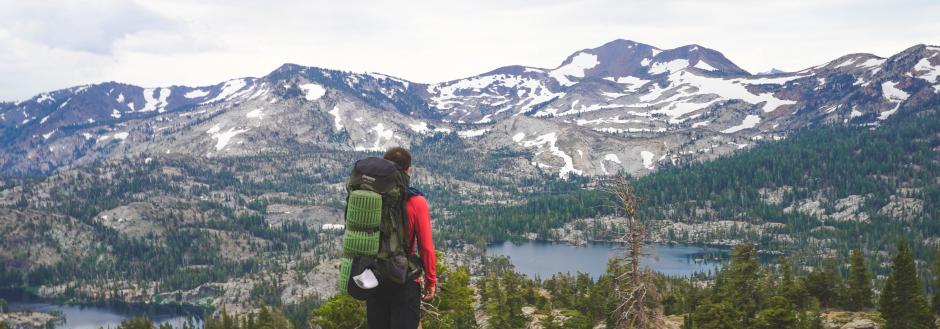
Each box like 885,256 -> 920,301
0,290 -> 202,329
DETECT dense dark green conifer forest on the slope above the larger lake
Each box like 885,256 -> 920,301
444,102 -> 940,271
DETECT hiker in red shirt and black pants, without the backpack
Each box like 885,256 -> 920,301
366,147 -> 437,329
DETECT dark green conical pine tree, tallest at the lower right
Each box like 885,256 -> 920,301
878,239 -> 934,329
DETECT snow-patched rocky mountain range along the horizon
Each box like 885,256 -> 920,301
0,40 -> 940,178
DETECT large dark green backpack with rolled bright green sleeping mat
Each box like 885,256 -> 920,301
339,157 -> 421,299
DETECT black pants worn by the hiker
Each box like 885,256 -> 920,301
366,280 -> 421,329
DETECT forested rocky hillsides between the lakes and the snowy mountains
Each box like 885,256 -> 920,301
0,94 -> 940,318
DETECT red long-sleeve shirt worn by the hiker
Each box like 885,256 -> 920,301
405,195 -> 437,286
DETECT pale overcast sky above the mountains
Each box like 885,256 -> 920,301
0,0 -> 940,101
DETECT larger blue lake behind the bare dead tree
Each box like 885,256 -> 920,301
486,241 -> 729,279
